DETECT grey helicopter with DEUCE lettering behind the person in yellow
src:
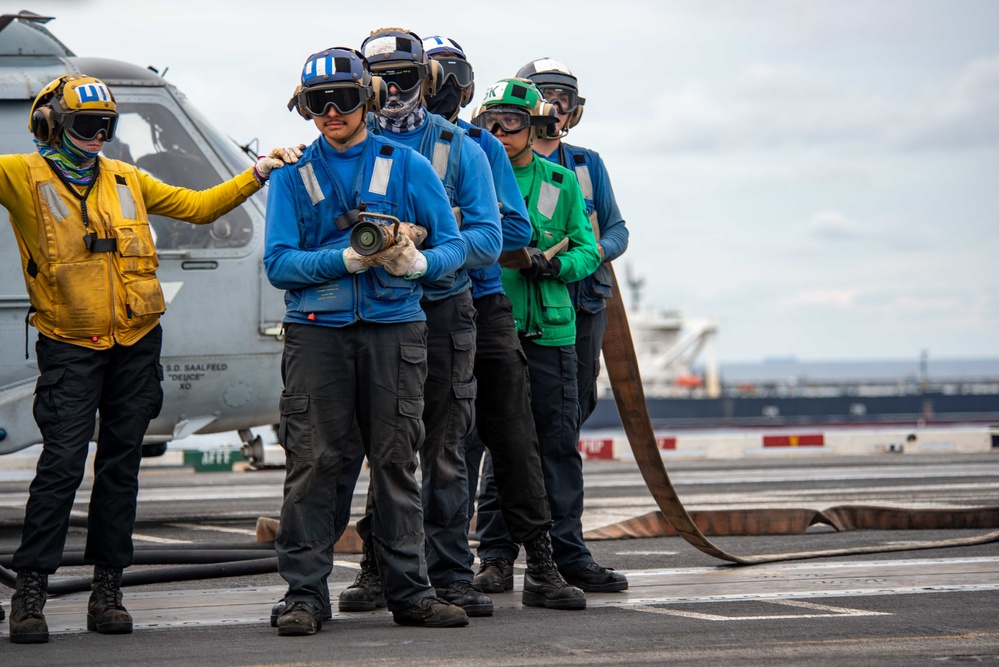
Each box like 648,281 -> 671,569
0,12 -> 284,460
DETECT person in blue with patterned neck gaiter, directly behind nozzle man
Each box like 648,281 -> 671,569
338,28 -> 502,616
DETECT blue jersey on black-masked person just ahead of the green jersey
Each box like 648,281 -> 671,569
458,118 -> 531,299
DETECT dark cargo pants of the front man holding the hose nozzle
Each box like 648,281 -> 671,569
275,322 -> 434,611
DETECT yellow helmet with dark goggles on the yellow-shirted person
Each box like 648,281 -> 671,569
28,74 -> 118,144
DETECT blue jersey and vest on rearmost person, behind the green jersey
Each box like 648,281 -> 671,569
541,142 -> 628,313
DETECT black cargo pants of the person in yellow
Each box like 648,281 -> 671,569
12,325 -> 163,574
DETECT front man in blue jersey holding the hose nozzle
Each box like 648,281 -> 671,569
264,48 -> 468,636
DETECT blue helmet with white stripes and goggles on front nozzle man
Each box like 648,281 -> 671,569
288,47 -> 387,120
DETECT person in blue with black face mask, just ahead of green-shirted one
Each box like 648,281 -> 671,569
423,36 -> 586,609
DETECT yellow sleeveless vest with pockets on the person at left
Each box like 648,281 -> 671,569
18,153 -> 166,349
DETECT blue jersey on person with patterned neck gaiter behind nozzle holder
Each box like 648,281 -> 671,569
368,111 -> 503,301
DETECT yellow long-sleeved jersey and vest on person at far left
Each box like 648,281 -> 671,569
0,153 -> 260,350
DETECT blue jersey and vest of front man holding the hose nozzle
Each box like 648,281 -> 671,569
264,134 -> 465,327
